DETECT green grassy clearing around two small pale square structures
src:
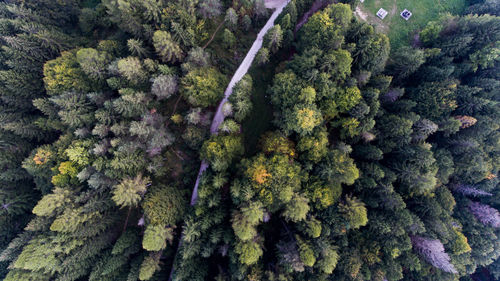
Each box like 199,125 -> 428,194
357,0 -> 467,48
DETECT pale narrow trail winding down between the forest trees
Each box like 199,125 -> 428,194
191,0 -> 290,206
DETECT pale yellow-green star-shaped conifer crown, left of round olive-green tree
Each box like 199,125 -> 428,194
113,174 -> 150,207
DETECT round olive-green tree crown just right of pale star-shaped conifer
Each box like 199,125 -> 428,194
142,185 -> 187,225
